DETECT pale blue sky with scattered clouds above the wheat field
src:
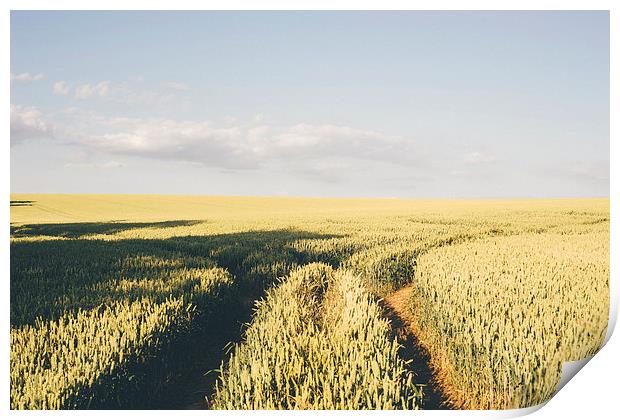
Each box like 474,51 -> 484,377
10,11 -> 610,198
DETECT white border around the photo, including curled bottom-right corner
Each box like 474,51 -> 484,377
0,0 -> 620,419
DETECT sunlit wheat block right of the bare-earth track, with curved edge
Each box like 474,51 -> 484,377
412,231 -> 609,408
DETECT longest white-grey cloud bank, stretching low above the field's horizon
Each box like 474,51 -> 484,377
9,108 -> 417,176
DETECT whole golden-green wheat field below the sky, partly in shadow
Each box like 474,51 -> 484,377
10,194 -> 610,409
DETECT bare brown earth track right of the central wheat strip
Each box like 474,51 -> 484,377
382,286 -> 450,410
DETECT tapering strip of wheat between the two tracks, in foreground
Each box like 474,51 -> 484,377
214,264 -> 420,409
